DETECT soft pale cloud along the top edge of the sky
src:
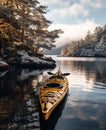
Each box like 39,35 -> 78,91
39,0 -> 103,17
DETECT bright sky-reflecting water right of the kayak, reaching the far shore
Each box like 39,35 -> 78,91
52,57 -> 106,130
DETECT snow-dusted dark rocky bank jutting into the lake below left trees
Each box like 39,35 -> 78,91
0,51 -> 56,69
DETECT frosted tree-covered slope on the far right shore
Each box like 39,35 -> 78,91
61,25 -> 106,57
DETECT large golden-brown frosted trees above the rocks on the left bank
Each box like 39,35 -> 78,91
0,0 -> 62,58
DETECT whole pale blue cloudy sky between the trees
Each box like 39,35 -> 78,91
39,0 -> 106,47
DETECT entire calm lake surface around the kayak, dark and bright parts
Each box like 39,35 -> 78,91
0,56 -> 106,130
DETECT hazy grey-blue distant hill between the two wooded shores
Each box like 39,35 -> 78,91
44,47 -> 61,55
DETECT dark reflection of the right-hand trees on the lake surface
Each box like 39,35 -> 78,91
72,61 -> 106,83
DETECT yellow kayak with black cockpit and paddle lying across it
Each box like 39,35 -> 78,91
39,70 -> 69,120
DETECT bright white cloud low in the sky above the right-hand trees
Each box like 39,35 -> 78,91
49,20 -> 98,47
